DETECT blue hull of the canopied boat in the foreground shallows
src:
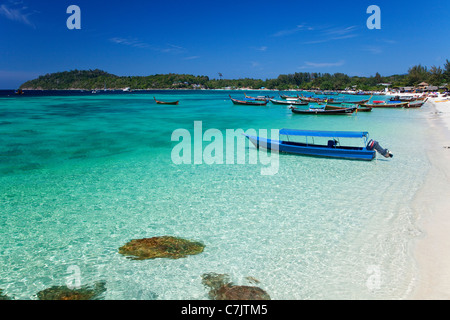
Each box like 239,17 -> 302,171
246,135 -> 376,161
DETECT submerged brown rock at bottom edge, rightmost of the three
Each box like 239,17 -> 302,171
202,273 -> 270,300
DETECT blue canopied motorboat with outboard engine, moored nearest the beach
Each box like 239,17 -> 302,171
245,129 -> 393,161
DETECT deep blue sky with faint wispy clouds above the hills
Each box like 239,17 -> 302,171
0,0 -> 450,88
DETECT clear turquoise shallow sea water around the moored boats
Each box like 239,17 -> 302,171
0,91 -> 430,299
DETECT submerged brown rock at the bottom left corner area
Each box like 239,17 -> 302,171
37,281 -> 106,300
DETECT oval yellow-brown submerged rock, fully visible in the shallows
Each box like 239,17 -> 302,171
119,236 -> 205,260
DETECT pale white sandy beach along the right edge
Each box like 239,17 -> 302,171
407,98 -> 450,300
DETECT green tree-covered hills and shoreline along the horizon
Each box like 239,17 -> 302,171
20,60 -> 450,90
